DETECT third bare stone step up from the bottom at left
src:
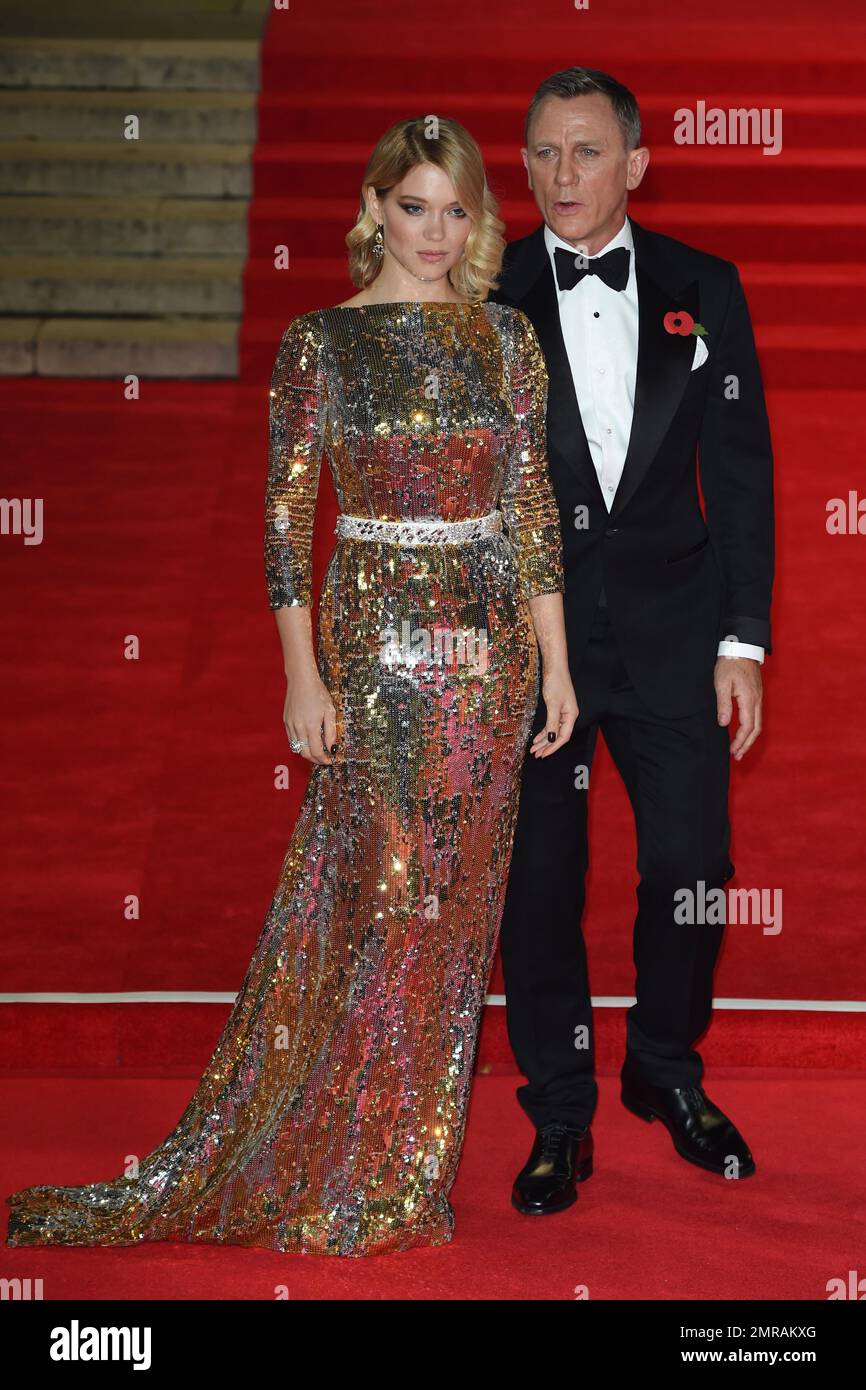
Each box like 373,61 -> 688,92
0,197 -> 249,257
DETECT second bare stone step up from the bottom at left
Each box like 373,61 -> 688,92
0,256 -> 245,318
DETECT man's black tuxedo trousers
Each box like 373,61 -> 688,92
500,606 -> 734,1127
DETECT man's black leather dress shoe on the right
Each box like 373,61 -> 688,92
621,1063 -> 755,1177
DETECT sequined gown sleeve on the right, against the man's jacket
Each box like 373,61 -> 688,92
499,310 -> 564,598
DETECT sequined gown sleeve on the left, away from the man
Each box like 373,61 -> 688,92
264,314 -> 327,609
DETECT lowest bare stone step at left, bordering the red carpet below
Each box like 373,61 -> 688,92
0,317 -> 239,381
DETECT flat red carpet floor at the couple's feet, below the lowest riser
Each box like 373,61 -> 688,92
0,1073 -> 866,1301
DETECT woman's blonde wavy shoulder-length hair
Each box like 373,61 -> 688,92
346,115 -> 505,300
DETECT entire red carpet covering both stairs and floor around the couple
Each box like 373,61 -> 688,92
0,0 -> 866,1298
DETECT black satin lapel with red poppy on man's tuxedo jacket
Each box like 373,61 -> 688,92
610,257 -> 701,520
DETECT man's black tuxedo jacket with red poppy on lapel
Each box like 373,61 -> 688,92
489,218 -> 774,719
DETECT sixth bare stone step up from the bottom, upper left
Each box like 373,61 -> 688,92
0,36 -> 259,92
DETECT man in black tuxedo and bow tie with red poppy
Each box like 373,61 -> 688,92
492,68 -> 773,1213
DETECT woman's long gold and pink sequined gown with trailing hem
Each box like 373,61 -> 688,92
7,302 -> 563,1255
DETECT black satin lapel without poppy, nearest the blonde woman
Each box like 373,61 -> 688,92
505,247 -> 603,506
